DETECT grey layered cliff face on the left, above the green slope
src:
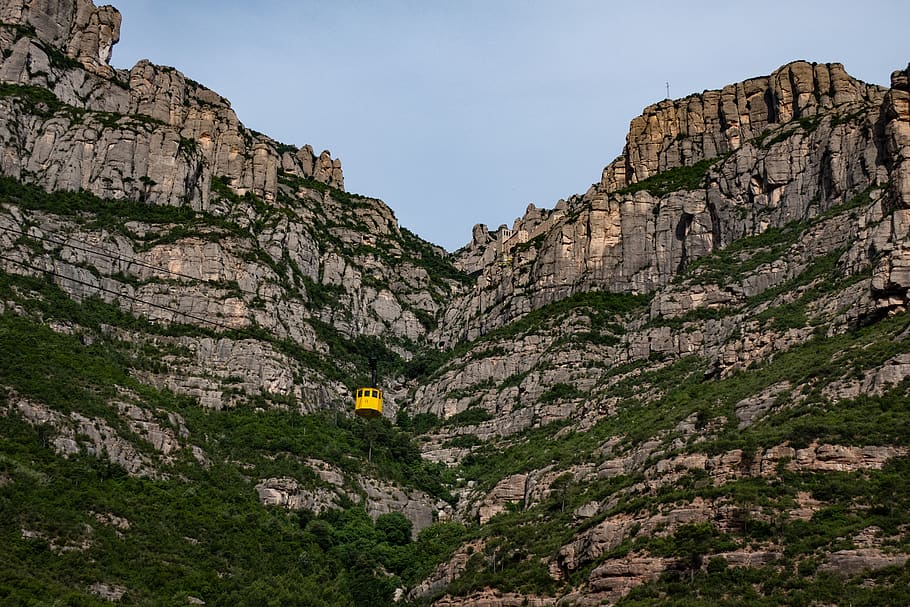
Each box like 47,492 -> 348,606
0,0 -> 466,413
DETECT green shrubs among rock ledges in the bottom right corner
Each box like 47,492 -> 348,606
619,458 -> 910,607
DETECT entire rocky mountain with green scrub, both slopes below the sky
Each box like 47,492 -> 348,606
0,0 -> 910,607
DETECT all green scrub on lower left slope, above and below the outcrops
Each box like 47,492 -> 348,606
0,294 -> 463,606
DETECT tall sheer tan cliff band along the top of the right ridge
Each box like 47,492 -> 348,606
444,62 -> 906,350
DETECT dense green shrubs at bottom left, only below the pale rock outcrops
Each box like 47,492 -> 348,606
0,416 -> 463,607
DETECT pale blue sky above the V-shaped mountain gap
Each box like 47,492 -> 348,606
112,0 -> 910,250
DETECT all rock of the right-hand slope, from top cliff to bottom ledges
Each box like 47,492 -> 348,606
409,63 -> 910,607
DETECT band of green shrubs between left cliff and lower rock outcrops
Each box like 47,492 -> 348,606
0,291 -> 450,499
